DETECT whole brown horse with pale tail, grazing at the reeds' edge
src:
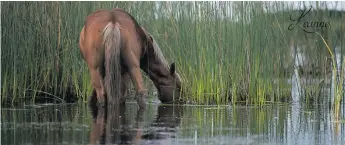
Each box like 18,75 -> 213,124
79,9 -> 181,107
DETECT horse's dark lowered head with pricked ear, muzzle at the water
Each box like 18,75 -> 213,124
156,63 -> 181,103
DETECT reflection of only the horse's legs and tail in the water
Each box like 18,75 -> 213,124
90,105 -> 143,145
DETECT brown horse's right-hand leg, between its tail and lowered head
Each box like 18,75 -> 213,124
122,50 -> 147,108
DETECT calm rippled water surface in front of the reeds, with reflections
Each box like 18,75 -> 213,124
1,103 -> 345,145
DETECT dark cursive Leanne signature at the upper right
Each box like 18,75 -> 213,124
288,7 -> 331,33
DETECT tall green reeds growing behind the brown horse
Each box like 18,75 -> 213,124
1,2 -> 343,105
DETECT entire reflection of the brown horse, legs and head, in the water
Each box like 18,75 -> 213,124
90,104 -> 182,145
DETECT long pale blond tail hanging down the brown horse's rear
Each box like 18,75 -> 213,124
102,22 -> 122,104
